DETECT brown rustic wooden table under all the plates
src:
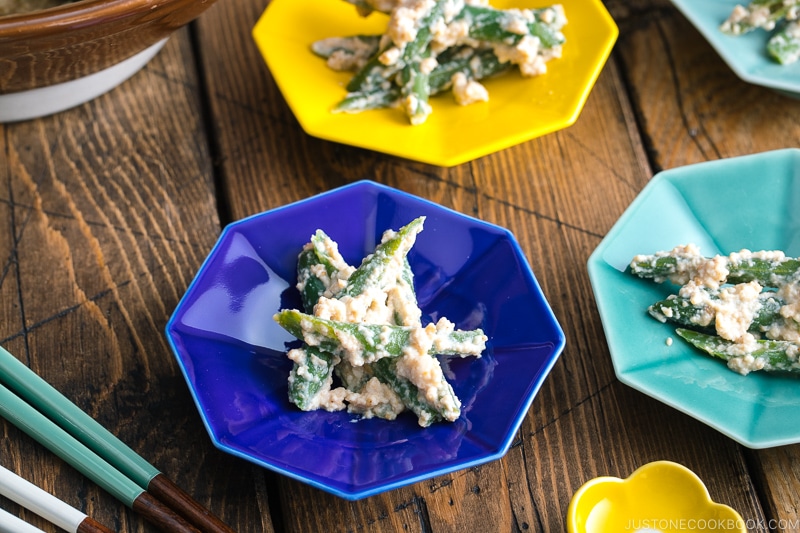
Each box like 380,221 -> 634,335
0,0 -> 800,533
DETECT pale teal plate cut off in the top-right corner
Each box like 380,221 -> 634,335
672,0 -> 800,97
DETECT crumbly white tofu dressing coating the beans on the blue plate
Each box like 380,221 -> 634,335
289,220 -> 487,426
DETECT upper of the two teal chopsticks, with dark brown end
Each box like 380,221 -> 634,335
0,347 -> 234,533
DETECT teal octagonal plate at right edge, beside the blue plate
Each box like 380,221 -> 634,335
588,149 -> 800,448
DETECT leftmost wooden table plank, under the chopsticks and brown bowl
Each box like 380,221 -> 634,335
0,29 -> 271,533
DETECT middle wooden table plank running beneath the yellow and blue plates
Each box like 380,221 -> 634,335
198,0 -> 780,533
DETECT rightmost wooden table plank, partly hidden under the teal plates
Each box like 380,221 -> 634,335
611,1 -> 800,531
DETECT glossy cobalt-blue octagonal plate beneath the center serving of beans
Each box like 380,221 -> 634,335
166,181 -> 565,500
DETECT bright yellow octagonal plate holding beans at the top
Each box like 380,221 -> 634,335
253,0 -> 619,166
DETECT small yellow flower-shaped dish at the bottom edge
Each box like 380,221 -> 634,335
567,461 -> 747,533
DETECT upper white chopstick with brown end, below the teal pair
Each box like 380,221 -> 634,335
0,466 -> 113,533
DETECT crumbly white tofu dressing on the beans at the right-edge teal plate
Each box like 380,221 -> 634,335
633,244 -> 800,375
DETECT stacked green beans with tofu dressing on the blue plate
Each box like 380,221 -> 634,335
274,217 -> 487,427
